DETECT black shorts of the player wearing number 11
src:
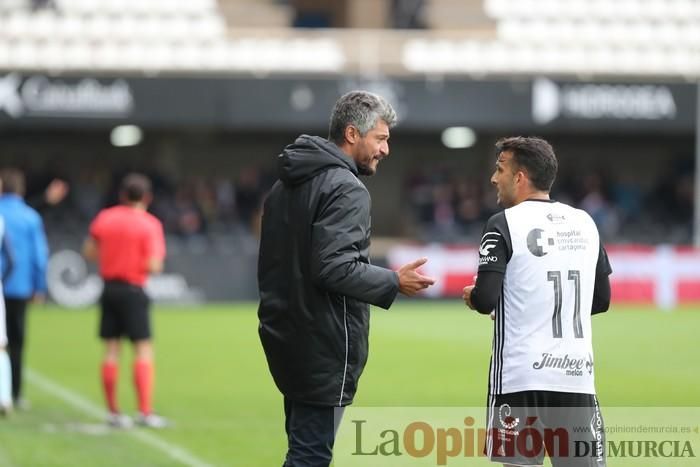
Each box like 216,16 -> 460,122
484,391 -> 606,467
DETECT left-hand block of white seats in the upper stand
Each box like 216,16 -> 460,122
0,0 -> 342,73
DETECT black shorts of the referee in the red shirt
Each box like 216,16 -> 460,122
100,281 -> 151,342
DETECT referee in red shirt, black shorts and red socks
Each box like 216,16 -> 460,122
83,174 -> 167,428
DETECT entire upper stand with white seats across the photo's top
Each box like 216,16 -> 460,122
0,0 -> 700,78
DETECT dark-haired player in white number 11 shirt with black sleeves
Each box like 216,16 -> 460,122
463,137 -> 612,467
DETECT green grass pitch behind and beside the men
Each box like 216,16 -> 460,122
0,300 -> 700,467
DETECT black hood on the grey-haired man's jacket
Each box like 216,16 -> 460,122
277,135 -> 357,186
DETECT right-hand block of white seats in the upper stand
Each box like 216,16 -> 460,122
403,0 -> 700,77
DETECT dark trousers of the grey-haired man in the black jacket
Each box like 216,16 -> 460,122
282,397 -> 344,467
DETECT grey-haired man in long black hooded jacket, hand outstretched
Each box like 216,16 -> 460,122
258,91 -> 434,467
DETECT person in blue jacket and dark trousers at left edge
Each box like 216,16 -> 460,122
0,168 -> 49,408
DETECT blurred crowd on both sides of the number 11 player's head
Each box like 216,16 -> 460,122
405,164 -> 694,244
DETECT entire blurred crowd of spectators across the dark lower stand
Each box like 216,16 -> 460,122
15,160 -> 694,244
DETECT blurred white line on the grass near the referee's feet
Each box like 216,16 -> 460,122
25,368 -> 213,467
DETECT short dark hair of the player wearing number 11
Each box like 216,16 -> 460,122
496,136 -> 559,192
